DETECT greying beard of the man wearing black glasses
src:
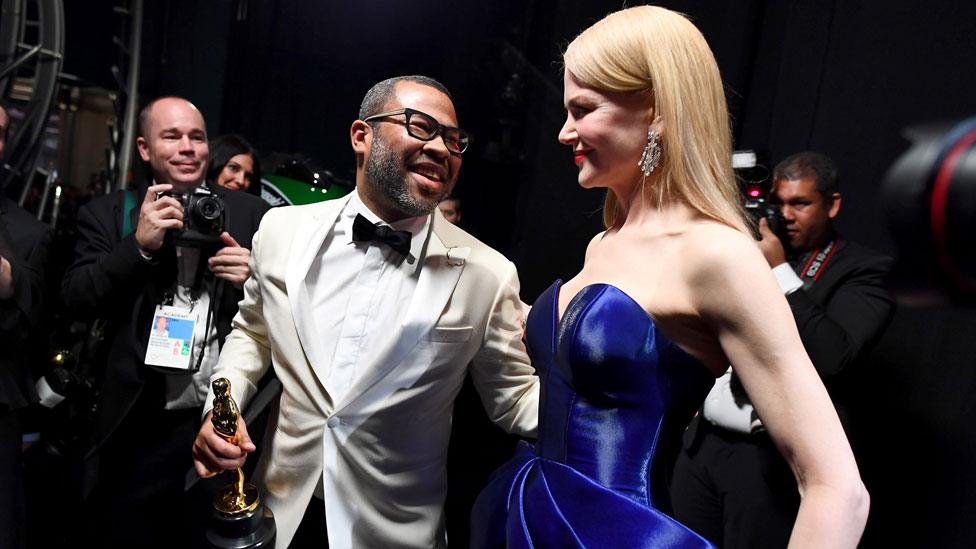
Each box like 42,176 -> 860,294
366,138 -> 450,217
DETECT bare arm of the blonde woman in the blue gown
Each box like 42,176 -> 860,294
686,228 -> 868,548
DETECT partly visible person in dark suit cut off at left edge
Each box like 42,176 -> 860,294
0,106 -> 51,547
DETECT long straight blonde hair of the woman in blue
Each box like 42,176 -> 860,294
563,6 -> 749,233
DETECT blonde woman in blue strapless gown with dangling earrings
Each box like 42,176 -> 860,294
472,6 -> 868,548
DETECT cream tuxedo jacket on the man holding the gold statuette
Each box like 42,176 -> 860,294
206,197 -> 539,549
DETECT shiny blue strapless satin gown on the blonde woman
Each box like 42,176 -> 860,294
471,281 -> 714,549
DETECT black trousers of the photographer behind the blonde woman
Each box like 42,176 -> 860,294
671,420 -> 800,549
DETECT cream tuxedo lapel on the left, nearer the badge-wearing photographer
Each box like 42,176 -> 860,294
285,195 -> 350,387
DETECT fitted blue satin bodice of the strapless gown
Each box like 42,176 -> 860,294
526,281 -> 714,505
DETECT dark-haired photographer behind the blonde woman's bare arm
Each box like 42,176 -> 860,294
671,152 -> 894,548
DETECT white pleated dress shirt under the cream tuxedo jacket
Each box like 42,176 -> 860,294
305,192 -> 431,402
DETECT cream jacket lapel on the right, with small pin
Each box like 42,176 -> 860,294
336,220 -> 471,413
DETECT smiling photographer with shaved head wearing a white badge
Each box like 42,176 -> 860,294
62,97 -> 268,547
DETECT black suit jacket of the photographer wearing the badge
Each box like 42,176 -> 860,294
62,185 -> 269,451
